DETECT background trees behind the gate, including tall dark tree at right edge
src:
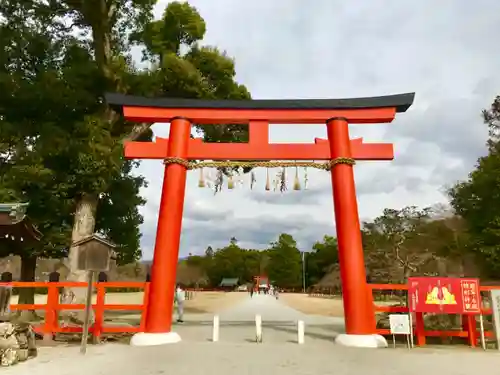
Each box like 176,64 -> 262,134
179,96 -> 500,288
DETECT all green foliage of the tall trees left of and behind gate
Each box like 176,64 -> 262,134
0,0 -> 256,270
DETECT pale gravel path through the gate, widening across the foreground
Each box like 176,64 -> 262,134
2,295 -> 500,375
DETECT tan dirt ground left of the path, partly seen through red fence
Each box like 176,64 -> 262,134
11,292 -> 247,313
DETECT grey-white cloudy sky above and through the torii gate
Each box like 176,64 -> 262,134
132,0 -> 500,259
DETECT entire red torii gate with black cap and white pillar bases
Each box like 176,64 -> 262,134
106,93 -> 414,347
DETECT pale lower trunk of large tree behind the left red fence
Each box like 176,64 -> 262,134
61,194 -> 99,324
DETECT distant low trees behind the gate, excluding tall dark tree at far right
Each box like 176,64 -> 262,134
178,207 -> 480,290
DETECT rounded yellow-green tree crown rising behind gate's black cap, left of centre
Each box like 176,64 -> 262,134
133,2 -> 250,147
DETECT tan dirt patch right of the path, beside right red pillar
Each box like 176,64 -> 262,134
280,293 -> 344,317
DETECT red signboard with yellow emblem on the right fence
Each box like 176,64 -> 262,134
408,277 -> 481,314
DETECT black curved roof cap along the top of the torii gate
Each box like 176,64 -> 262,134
105,93 -> 415,112
